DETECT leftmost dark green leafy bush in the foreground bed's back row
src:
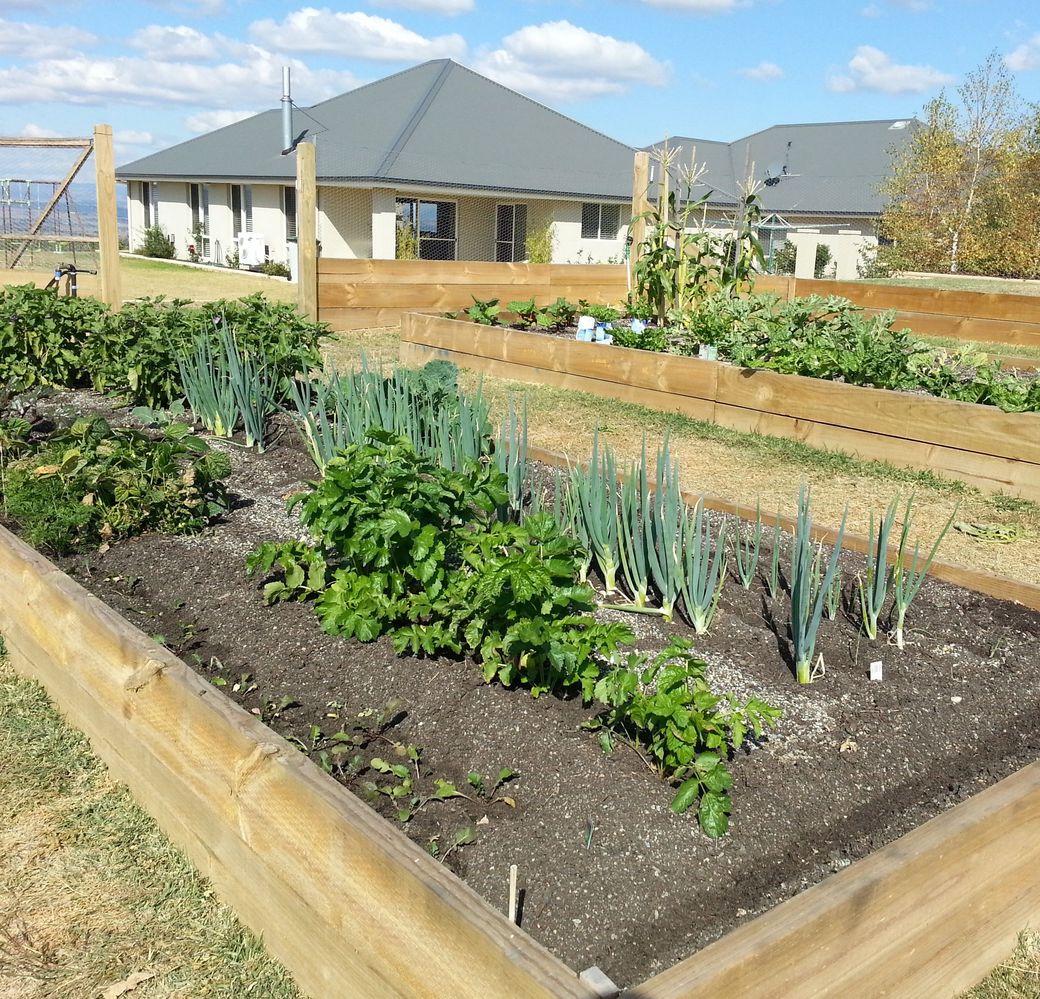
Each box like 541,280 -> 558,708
0,285 -> 107,392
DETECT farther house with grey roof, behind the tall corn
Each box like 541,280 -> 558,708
647,119 -> 919,280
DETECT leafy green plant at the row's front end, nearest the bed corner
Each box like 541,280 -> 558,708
596,638 -> 780,837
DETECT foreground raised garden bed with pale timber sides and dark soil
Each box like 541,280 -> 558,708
0,390 -> 1040,999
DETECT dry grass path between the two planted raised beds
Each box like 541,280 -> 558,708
329,327 -> 1040,583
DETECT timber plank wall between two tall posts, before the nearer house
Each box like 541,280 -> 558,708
317,258 -> 628,331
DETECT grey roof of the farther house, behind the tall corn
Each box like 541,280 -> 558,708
647,119 -> 919,217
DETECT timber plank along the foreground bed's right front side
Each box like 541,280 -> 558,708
625,763 -> 1040,999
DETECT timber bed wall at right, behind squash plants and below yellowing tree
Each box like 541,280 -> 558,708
755,275 -> 1040,347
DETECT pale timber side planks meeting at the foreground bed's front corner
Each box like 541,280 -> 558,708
0,517 -> 1040,999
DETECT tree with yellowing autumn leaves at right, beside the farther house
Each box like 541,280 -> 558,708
878,51 -> 1026,273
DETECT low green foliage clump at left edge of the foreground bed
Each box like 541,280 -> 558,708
3,418 -> 231,554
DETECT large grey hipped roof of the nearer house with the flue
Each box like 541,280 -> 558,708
116,59 -> 634,201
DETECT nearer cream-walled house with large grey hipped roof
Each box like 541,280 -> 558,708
116,59 -> 635,272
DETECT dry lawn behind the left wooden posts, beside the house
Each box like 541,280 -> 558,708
0,257 -> 296,301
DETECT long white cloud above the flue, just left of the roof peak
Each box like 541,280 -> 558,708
250,7 -> 466,62
